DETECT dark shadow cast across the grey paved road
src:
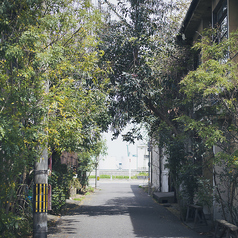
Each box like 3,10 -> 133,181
49,185 -> 204,238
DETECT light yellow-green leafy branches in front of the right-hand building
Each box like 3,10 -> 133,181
180,27 -> 238,151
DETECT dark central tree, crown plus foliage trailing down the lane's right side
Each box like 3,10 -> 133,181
100,0 -> 197,215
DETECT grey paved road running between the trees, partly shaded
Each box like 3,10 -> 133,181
48,181 -> 208,238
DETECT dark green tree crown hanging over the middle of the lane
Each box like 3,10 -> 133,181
100,1 -> 191,141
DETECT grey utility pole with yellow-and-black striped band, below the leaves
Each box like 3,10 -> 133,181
33,147 -> 48,238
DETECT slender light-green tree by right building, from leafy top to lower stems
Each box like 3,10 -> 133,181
181,29 -> 238,223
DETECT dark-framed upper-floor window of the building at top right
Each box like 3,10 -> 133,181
213,0 -> 228,43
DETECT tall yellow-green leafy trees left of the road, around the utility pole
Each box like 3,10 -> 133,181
0,0 -> 108,236
